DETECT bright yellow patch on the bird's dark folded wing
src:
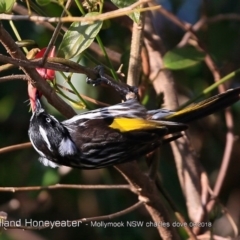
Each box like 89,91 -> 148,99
109,118 -> 165,132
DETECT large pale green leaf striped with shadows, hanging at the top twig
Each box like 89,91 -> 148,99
58,12 -> 102,59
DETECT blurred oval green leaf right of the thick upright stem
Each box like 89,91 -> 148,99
163,46 -> 205,70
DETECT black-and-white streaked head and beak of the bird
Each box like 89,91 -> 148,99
28,94 -> 78,165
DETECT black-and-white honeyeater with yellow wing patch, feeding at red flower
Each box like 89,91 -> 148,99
28,88 -> 240,169
